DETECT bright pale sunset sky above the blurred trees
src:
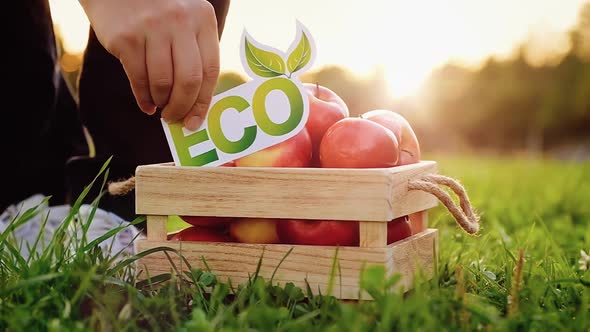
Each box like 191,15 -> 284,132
50,0 -> 586,97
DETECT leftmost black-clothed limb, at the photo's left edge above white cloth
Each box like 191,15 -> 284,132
0,0 -> 87,212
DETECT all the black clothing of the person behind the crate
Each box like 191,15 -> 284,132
0,0 -> 229,220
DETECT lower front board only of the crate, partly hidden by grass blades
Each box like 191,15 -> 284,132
138,240 -> 393,299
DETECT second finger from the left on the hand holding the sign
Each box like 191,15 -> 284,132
145,31 -> 174,107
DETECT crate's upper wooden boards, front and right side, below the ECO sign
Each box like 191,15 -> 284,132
136,161 -> 437,221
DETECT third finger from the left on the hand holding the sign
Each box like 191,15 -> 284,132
162,29 -> 203,122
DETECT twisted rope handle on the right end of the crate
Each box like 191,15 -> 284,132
408,174 -> 479,234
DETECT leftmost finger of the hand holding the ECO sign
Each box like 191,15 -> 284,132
119,42 -> 156,115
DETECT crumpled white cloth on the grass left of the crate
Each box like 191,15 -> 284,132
0,194 -> 139,259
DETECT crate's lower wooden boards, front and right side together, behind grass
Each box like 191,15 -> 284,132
137,229 -> 438,299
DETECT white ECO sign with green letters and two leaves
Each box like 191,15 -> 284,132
162,23 -> 315,166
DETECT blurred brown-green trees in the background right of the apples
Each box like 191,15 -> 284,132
421,2 -> 590,153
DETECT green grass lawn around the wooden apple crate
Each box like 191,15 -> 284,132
0,158 -> 590,331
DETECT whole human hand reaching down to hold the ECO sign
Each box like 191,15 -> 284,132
80,0 -> 219,130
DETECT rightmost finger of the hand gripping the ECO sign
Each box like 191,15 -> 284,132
197,24 -> 219,117
